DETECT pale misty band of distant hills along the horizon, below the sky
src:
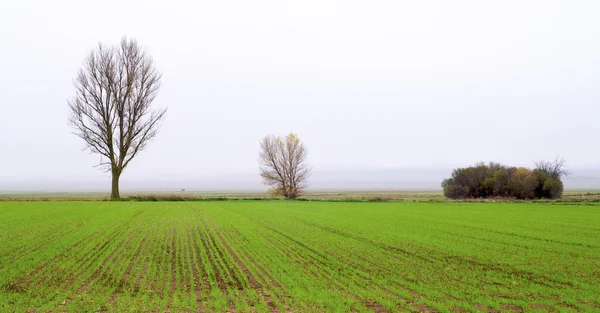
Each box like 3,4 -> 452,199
0,167 -> 600,194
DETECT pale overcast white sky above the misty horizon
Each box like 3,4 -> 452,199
0,0 -> 600,188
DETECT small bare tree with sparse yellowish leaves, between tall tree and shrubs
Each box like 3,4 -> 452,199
259,133 -> 310,199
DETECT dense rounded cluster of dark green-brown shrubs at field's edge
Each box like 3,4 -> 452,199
442,162 -> 563,199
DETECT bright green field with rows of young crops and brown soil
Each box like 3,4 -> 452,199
0,201 -> 600,312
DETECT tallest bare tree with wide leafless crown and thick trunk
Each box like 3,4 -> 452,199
68,38 -> 166,199
